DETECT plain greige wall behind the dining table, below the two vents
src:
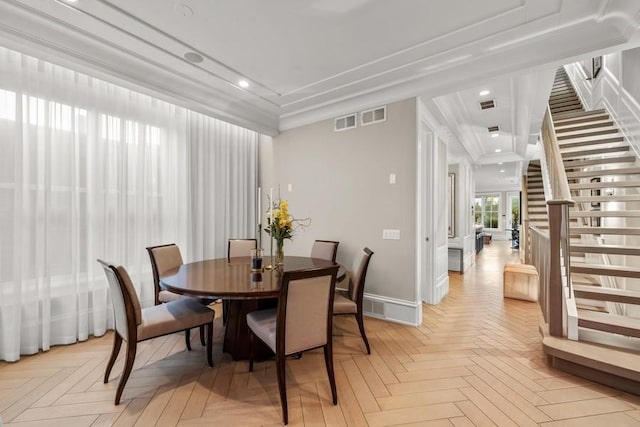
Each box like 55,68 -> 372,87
260,98 -> 417,321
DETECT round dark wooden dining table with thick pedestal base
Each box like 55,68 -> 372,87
160,256 -> 345,360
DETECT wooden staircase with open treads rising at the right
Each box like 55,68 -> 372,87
527,68 -> 640,394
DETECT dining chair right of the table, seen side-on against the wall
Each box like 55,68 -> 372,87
333,248 -> 373,354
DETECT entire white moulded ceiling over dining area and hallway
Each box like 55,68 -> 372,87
0,0 -> 640,190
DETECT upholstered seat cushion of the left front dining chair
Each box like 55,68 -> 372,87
138,298 -> 215,341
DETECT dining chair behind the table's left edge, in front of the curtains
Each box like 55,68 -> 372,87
147,243 -> 213,350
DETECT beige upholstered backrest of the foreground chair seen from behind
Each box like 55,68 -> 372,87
276,265 -> 338,355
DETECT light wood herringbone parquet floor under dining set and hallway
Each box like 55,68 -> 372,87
0,241 -> 640,427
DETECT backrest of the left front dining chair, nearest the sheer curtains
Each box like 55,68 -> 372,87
98,260 -> 142,341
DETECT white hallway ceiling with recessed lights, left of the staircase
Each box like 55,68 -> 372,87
433,67 -> 556,191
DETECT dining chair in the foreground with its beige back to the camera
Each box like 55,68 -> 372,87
247,265 -> 338,424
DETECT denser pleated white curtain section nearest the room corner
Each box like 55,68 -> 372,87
189,112 -> 258,260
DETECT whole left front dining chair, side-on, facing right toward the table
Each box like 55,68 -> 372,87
98,260 -> 215,405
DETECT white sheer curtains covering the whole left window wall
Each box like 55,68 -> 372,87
0,47 -> 257,361
